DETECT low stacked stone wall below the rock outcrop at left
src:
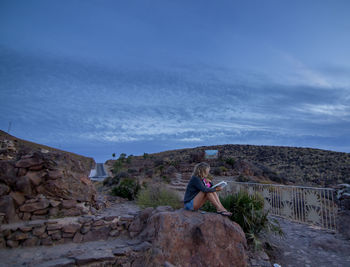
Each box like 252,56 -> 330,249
0,215 -> 135,248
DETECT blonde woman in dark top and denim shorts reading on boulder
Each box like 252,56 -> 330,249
184,162 -> 232,216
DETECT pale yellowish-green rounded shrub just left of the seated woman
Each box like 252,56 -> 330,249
136,184 -> 183,209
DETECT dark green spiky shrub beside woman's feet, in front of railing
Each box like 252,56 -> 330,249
202,192 -> 283,248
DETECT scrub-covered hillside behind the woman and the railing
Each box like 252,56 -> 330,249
106,145 -> 350,191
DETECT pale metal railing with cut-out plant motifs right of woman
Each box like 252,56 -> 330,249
220,182 -> 338,231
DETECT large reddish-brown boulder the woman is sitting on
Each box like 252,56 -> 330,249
135,210 -> 247,267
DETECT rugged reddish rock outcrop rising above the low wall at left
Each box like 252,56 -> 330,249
0,133 -> 96,224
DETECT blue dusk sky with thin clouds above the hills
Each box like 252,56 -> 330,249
0,0 -> 350,162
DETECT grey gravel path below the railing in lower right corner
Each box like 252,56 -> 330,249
267,219 -> 350,267
